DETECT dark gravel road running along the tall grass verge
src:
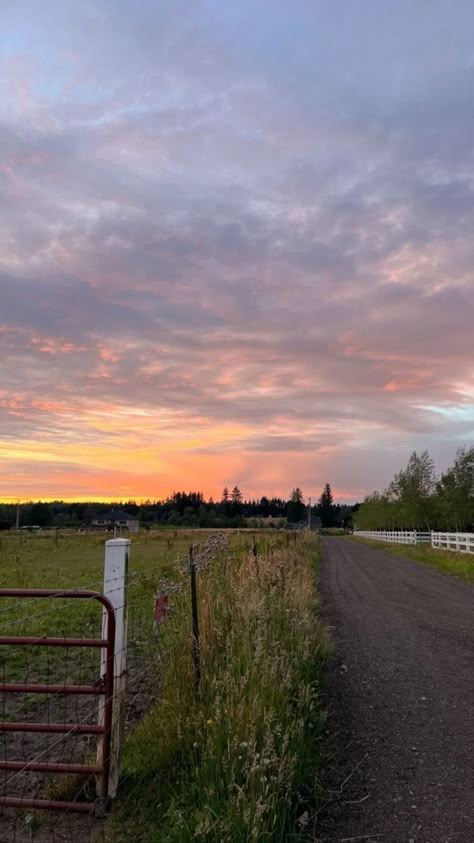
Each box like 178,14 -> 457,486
318,538 -> 474,843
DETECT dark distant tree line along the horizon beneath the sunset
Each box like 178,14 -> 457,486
0,483 -> 354,529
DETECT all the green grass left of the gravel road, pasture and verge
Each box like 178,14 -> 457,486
0,530 -> 327,843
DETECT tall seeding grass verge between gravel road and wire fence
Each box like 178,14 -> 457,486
104,537 -> 328,843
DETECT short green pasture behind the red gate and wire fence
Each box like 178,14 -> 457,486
0,531 -> 215,699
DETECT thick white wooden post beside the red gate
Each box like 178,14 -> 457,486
97,539 -> 131,797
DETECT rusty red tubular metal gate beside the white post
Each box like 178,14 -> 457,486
0,588 -> 115,812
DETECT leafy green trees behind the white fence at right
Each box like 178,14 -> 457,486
355,447 -> 474,532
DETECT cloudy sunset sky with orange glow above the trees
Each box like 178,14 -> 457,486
0,0 -> 474,503
